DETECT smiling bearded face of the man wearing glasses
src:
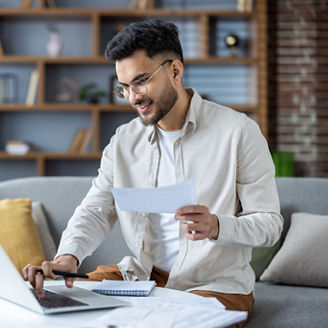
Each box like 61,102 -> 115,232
116,50 -> 178,125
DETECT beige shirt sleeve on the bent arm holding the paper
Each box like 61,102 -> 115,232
216,117 -> 283,247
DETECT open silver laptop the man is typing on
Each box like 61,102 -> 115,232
0,245 -> 130,314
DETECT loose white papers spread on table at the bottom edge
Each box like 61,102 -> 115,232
83,296 -> 247,328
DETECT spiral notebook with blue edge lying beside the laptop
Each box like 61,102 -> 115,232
92,279 -> 156,296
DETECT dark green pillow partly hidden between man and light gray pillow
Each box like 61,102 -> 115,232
250,239 -> 281,280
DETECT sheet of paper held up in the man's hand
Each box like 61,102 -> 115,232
112,179 -> 197,213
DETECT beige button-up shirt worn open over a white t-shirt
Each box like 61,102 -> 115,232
57,90 -> 283,294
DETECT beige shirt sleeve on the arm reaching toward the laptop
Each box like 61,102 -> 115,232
56,137 -> 117,264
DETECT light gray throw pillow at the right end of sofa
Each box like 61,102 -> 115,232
260,213 -> 328,287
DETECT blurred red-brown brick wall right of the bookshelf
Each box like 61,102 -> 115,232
266,0 -> 328,177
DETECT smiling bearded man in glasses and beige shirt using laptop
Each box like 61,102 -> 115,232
23,20 -> 283,326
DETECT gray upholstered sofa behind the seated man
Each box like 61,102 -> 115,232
0,177 -> 328,328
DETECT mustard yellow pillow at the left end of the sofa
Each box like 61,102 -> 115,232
0,199 -> 45,274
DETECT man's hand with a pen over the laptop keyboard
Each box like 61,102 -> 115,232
23,254 -> 78,298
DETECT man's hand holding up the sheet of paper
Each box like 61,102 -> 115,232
175,205 -> 219,240
